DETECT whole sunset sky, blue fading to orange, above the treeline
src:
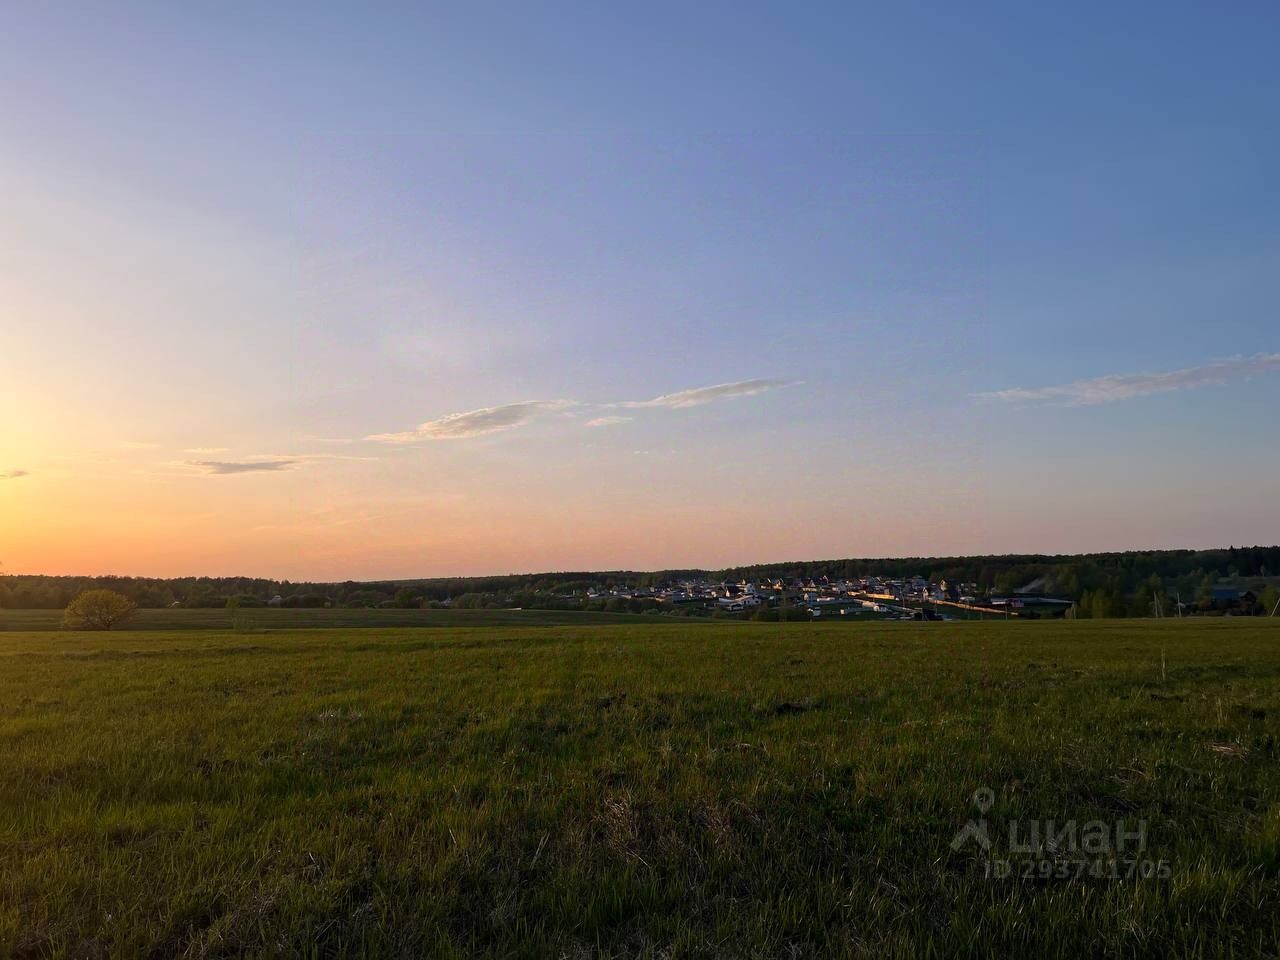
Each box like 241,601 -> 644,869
0,1 -> 1280,580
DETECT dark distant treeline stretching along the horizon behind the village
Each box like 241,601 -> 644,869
0,547 -> 1280,616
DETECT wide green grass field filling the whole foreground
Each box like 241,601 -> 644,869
0,618 -> 1280,957
